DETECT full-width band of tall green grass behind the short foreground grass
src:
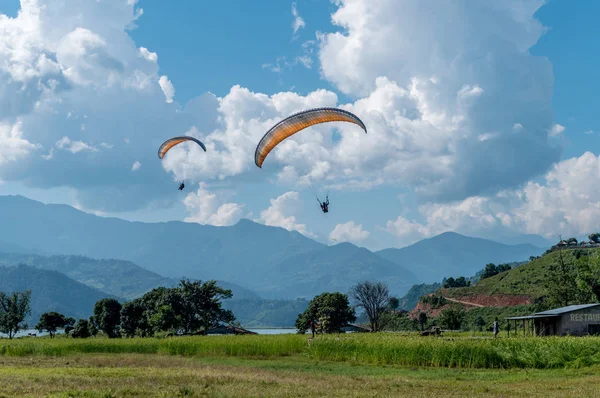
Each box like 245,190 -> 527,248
0,333 -> 600,369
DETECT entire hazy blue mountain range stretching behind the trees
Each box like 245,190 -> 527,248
0,196 -> 544,324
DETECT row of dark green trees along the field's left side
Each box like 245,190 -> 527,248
0,279 -> 235,339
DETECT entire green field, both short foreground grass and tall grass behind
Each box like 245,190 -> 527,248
0,333 -> 600,397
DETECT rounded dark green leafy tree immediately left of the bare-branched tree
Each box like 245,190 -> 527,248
296,292 -> 356,334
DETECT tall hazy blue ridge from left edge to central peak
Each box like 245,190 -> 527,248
0,196 -> 325,296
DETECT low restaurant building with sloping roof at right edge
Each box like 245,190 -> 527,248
506,303 -> 600,336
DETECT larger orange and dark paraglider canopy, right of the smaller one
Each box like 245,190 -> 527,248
254,108 -> 367,168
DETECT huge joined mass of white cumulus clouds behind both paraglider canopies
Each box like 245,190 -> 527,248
0,0 -> 559,222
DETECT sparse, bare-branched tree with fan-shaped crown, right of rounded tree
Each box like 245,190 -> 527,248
350,281 -> 390,332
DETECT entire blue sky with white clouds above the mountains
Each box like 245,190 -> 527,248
0,0 -> 600,249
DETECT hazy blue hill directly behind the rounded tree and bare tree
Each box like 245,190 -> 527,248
258,243 -> 418,299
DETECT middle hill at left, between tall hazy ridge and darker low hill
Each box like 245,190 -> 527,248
0,252 -> 260,300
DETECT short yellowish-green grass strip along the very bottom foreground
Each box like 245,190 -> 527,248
0,354 -> 600,398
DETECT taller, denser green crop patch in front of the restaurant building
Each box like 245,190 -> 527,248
310,334 -> 600,369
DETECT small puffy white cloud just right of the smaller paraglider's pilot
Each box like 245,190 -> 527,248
183,184 -> 244,226
